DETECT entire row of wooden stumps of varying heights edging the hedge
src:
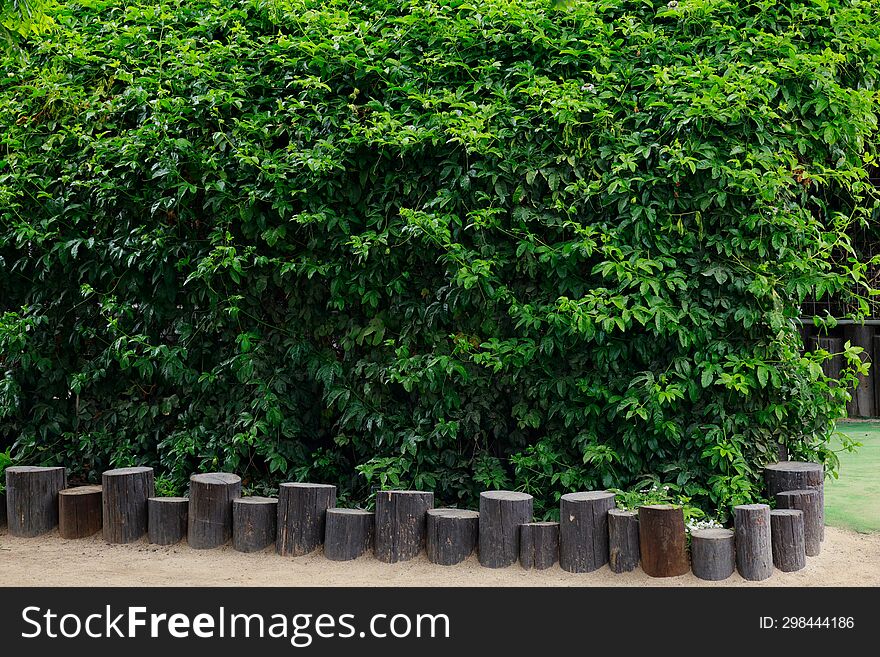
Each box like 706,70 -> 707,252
6,461 -> 824,580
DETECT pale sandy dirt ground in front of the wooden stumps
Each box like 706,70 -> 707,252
0,527 -> 880,587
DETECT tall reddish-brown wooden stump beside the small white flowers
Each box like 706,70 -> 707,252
639,504 -> 690,577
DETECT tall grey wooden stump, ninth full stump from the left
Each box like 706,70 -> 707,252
376,490 -> 434,563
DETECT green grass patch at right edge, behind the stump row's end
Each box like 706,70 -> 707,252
825,421 -> 880,532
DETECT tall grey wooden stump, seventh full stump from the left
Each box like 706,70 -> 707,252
275,483 -> 336,557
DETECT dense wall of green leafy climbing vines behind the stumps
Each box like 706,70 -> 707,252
0,0 -> 880,515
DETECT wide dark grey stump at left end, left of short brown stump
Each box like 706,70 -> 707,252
6,465 -> 67,538
